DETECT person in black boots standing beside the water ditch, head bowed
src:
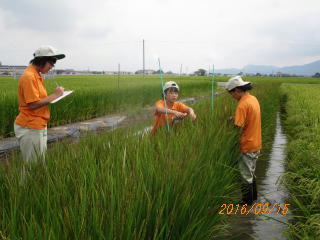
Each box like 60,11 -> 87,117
226,76 -> 262,205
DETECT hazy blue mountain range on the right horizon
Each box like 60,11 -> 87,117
216,60 -> 320,76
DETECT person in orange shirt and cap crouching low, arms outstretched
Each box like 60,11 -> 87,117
151,81 -> 197,134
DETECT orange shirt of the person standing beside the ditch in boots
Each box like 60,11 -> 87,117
234,93 -> 262,153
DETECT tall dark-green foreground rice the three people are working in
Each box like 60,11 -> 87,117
0,84 -> 279,240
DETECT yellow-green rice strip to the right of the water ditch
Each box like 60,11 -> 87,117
281,84 -> 320,239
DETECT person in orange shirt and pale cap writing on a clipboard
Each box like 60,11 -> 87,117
14,46 -> 65,162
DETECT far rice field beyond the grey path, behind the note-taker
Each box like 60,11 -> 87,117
0,76 -> 215,138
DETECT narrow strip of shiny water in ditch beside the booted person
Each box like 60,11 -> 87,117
225,114 -> 291,240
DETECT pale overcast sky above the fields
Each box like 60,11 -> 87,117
0,0 -> 320,73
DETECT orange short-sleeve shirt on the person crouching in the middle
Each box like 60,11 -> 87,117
151,100 -> 189,133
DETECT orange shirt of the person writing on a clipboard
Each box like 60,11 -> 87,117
15,65 -> 50,129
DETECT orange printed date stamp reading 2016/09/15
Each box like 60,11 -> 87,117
219,202 -> 290,215
